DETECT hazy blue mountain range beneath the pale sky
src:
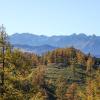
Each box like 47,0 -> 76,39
9,33 -> 100,56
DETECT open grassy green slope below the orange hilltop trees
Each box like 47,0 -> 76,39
46,64 -> 84,83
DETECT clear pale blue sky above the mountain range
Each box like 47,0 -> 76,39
0,0 -> 100,36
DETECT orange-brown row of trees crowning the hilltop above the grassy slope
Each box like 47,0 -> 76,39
42,47 -> 96,71
